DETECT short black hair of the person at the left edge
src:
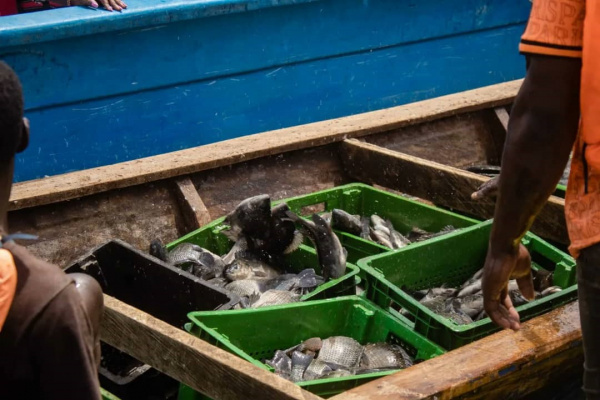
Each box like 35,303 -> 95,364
0,61 -> 23,161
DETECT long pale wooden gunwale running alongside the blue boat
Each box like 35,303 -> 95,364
10,80 -> 522,210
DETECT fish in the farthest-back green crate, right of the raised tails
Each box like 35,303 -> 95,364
323,208 -> 455,249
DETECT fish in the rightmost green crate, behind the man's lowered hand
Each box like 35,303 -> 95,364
401,269 -> 561,325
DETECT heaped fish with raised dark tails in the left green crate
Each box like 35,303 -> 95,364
150,195 -> 347,308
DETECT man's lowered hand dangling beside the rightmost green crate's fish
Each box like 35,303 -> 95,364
482,244 -> 535,330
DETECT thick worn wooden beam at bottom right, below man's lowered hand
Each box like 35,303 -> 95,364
332,302 -> 582,400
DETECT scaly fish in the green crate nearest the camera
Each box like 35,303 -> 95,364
265,336 -> 413,382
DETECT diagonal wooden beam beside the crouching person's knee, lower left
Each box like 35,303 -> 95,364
101,295 -> 320,400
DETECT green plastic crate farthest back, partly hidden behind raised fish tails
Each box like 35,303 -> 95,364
282,183 -> 480,263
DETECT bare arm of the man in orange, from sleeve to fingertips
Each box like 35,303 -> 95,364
483,55 -> 581,329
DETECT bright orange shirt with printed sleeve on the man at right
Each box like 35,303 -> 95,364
519,0 -> 600,257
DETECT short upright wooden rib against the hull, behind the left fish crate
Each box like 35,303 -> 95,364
174,176 -> 212,232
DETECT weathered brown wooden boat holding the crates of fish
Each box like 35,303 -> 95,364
4,81 -> 582,400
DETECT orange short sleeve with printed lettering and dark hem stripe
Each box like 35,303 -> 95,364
519,0 -> 584,58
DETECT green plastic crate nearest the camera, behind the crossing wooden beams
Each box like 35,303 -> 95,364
179,296 -> 444,400
